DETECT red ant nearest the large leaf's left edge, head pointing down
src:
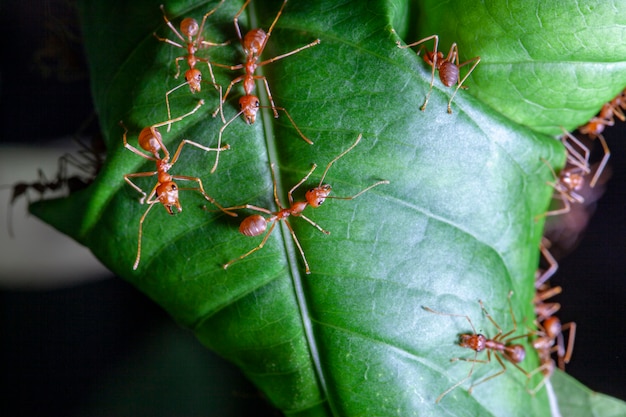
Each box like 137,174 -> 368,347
120,100 -> 237,269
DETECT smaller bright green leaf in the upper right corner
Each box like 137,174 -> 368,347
419,0 -> 626,135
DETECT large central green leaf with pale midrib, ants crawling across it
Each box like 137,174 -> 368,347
32,0 -> 624,416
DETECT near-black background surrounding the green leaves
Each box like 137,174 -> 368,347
0,1 -> 626,416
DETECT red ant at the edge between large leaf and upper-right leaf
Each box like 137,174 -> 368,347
396,35 -> 480,113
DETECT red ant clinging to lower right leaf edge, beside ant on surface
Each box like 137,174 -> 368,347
528,284 -> 576,395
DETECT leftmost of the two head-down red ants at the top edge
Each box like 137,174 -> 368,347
153,0 -> 230,127
